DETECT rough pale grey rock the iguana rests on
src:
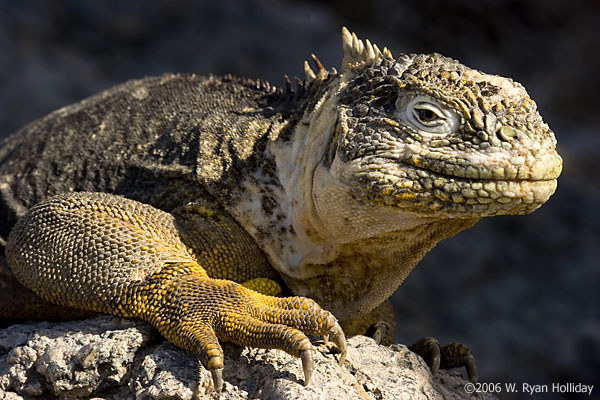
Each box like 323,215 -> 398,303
0,316 -> 494,400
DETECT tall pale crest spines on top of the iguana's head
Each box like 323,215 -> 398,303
342,26 -> 394,73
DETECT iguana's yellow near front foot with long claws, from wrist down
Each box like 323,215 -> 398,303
123,264 -> 346,391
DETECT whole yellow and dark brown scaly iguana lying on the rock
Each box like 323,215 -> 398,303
0,28 -> 562,390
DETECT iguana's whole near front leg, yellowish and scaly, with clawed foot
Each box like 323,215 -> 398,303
6,193 -> 346,390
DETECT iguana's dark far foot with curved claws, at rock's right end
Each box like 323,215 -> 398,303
408,337 -> 478,382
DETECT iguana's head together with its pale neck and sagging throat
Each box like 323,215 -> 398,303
264,29 -> 562,319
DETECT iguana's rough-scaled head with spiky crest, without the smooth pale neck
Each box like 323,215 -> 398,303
318,30 -> 562,218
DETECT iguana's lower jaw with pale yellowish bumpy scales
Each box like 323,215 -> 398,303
355,157 -> 557,216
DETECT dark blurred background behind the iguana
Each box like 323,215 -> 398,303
0,0 -> 600,399
